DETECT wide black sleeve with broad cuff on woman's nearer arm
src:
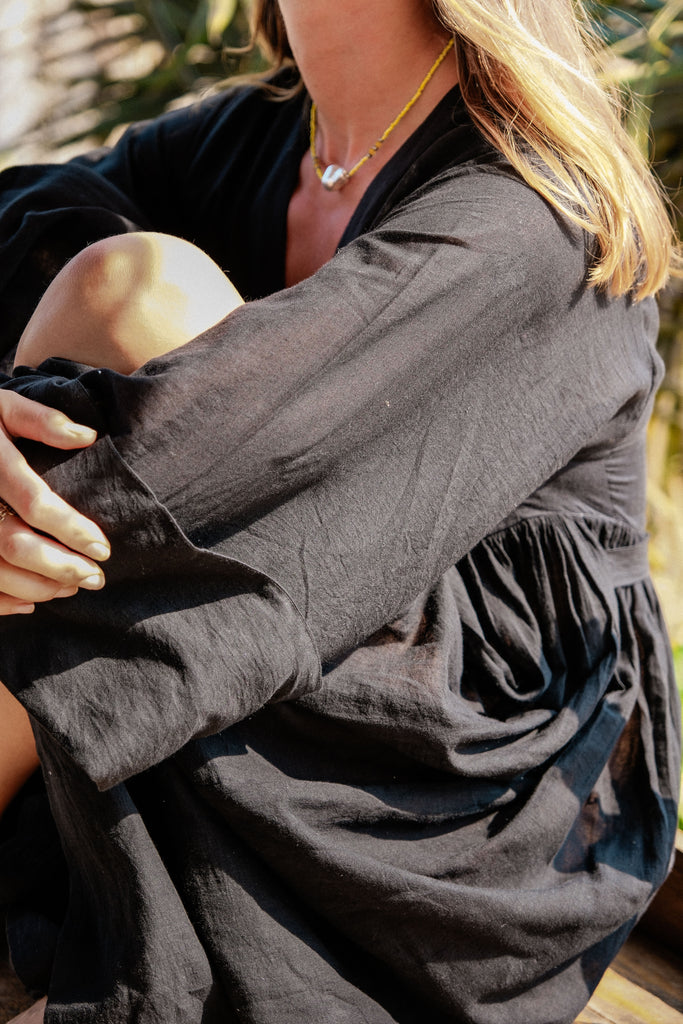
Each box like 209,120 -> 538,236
0,167 -> 658,787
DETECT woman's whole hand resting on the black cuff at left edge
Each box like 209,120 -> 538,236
0,391 -> 110,615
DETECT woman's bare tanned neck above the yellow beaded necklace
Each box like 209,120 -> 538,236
281,0 -> 457,167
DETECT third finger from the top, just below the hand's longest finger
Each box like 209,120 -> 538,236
0,516 -> 104,601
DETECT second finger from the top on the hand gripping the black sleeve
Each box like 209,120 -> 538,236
0,442 -> 111,561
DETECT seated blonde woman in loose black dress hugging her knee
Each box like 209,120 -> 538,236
0,0 -> 680,1024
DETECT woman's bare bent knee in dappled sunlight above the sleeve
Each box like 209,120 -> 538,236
15,232 -> 242,373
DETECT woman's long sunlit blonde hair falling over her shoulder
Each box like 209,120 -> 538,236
254,0 -> 682,299
